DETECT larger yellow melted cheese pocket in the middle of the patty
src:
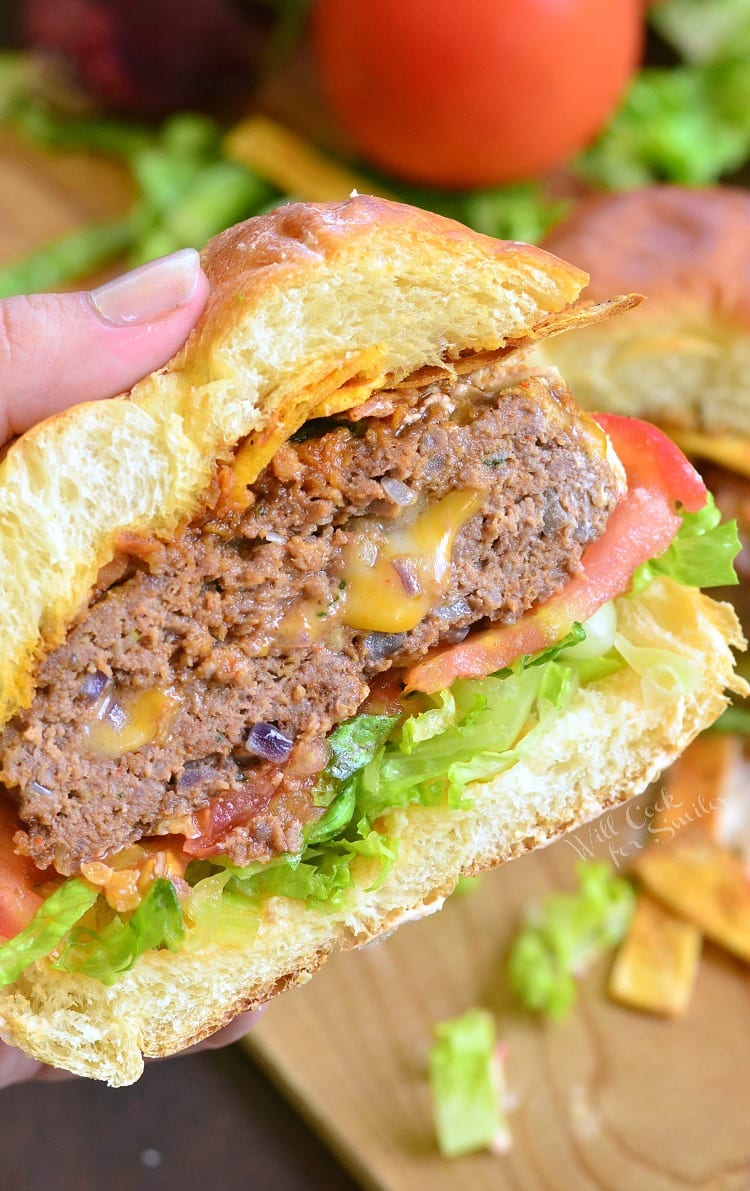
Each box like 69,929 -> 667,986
339,491 -> 485,632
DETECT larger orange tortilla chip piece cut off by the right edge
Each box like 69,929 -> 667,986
633,836 -> 750,964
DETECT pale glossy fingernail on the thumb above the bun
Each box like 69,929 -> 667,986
90,248 -> 200,326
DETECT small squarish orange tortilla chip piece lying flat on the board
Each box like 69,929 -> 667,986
607,893 -> 702,1017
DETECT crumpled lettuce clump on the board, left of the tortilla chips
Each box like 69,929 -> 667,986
507,861 -> 636,1018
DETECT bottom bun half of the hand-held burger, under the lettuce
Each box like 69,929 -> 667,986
0,579 -> 744,1086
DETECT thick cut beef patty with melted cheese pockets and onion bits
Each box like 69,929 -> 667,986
0,373 -> 618,873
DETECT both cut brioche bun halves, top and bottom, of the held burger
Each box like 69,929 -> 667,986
0,198 -> 742,1085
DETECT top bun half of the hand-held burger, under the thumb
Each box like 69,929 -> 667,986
0,197 -> 586,723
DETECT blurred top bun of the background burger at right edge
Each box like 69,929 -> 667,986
545,186 -> 750,436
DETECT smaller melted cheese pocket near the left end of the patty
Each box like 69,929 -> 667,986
85,688 -> 179,760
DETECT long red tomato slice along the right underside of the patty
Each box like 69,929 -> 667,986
406,413 -> 707,694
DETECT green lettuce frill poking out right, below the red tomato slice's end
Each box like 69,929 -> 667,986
631,493 -> 740,594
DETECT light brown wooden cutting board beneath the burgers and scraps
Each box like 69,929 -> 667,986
0,133 -> 750,1191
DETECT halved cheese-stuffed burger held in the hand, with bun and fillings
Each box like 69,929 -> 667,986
0,198 -> 742,1084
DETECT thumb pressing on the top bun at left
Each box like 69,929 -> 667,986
0,248 -> 208,443
